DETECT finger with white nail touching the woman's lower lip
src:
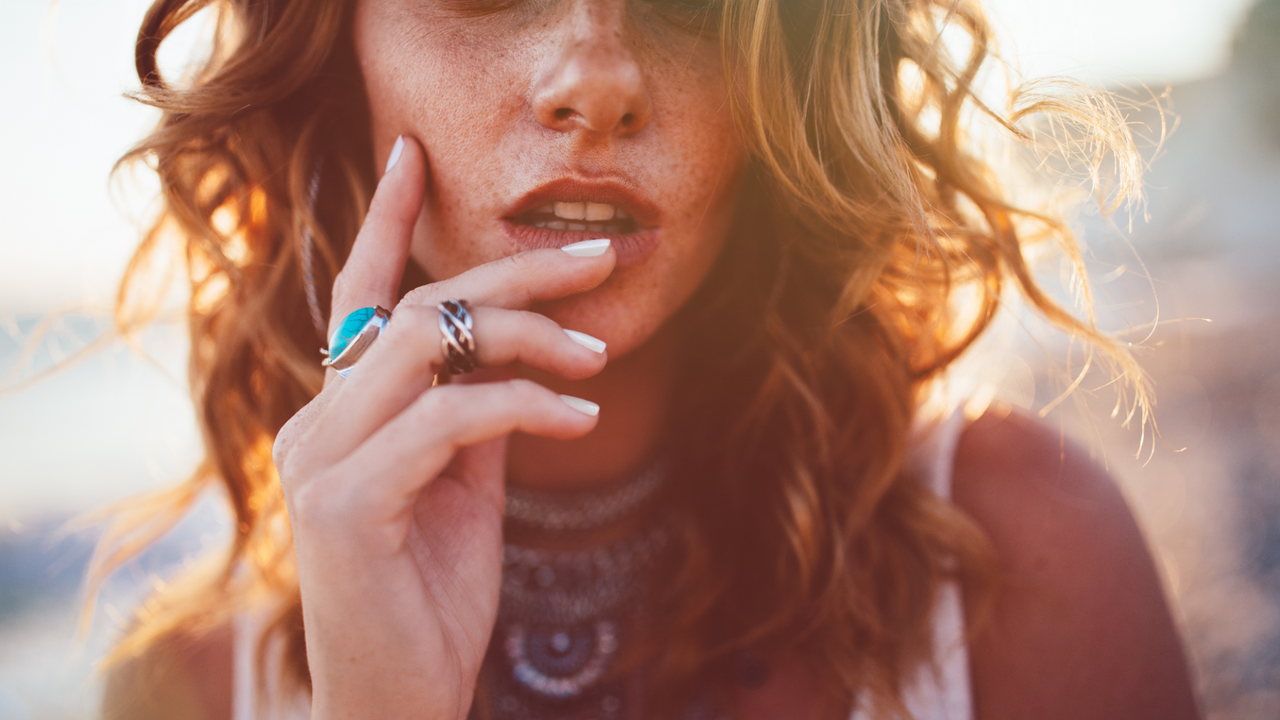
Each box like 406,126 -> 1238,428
401,240 -> 617,310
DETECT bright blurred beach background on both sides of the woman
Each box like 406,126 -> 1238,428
0,0 -> 1280,720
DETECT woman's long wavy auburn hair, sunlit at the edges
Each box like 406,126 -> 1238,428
95,0 -> 1146,716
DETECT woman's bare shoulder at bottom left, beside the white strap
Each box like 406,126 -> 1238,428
101,626 -> 233,720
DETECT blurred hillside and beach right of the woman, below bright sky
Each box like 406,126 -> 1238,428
1044,0 -> 1280,719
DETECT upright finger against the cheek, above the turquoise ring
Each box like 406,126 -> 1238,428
329,136 -> 426,337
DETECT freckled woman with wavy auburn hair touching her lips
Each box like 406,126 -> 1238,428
97,0 -> 1196,719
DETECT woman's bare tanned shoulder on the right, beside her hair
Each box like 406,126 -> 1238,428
952,411 -> 1197,720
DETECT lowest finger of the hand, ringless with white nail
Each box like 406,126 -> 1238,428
294,379 -> 599,523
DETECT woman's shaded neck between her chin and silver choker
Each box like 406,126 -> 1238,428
507,322 -> 676,489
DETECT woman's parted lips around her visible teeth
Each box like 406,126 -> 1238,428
500,178 -> 662,268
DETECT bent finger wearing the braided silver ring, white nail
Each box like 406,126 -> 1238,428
296,305 -> 608,462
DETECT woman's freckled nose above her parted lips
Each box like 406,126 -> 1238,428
532,0 -> 652,137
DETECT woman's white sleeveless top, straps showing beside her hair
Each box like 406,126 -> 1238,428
232,410 -> 973,720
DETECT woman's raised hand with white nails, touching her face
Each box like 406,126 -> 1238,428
274,138 -> 614,720
